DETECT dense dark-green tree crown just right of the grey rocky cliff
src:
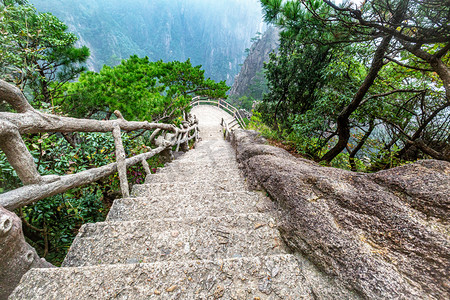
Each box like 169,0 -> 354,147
259,37 -> 331,129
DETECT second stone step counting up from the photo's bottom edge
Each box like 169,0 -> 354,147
63,213 -> 286,267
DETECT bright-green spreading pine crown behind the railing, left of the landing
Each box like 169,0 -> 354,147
60,55 -> 228,121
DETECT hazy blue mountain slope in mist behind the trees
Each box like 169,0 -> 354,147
30,0 -> 265,84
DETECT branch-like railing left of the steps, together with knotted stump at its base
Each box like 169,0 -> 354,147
0,80 -> 198,299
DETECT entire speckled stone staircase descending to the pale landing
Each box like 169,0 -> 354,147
10,106 -> 315,299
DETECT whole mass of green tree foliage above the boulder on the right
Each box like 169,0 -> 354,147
257,0 -> 450,171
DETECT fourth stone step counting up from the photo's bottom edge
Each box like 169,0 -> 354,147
131,178 -> 247,197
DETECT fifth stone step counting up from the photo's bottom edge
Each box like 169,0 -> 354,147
145,168 -> 244,183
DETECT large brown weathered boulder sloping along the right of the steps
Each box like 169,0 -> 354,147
233,130 -> 450,299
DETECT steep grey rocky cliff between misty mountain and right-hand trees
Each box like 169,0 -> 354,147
230,27 -> 279,97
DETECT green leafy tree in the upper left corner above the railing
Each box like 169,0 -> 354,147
0,1 -> 89,103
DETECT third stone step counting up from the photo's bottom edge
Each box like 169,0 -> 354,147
107,192 -> 272,221
